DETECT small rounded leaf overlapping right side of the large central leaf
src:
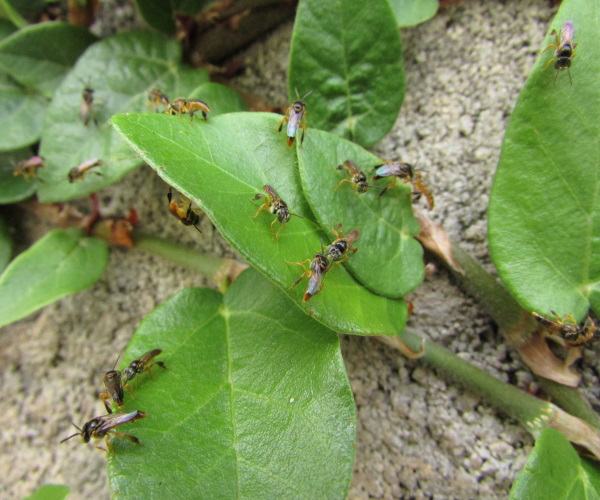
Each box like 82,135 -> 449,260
298,130 -> 424,298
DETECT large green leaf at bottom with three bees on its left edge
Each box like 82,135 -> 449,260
109,269 -> 356,500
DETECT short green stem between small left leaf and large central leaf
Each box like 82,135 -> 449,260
132,232 -> 248,291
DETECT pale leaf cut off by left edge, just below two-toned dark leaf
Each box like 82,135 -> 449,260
0,74 -> 48,151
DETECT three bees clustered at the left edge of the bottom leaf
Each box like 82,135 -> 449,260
61,349 -> 166,452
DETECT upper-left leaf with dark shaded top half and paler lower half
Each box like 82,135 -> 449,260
0,22 -> 96,99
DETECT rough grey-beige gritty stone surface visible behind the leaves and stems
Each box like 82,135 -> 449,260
0,0 -> 596,499
